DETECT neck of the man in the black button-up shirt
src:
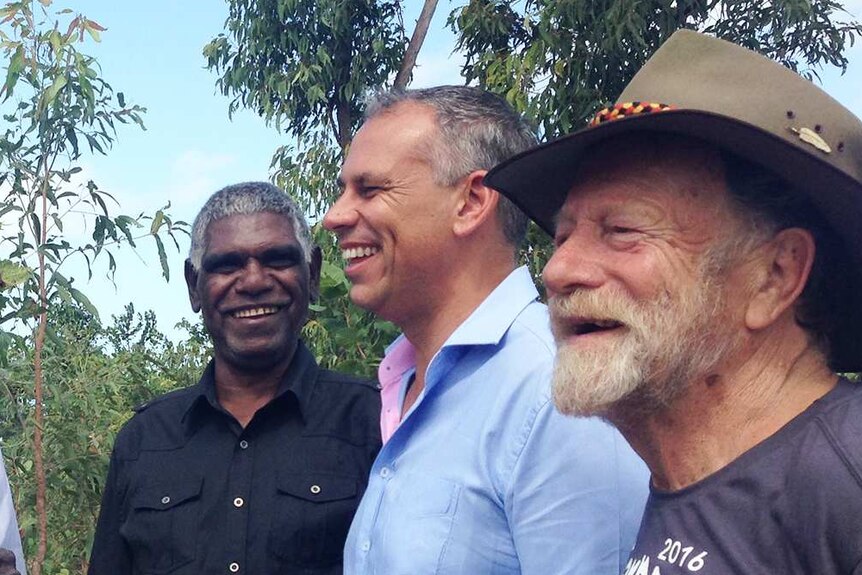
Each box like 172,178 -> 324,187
215,351 -> 296,427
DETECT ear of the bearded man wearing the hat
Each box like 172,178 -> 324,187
745,228 -> 815,330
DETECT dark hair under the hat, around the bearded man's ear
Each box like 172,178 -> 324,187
721,151 -> 854,364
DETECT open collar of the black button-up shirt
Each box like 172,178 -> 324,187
182,340 -> 319,428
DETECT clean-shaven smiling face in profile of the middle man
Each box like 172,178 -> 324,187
323,102 -> 458,328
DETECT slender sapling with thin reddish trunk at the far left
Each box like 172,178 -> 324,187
0,0 -> 184,575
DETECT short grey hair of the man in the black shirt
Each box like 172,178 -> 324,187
189,182 -> 312,269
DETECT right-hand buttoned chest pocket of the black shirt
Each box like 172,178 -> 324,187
269,473 -> 360,567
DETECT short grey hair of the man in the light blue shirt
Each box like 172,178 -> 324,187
365,86 -> 537,248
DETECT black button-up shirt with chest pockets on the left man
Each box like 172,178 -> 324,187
89,342 -> 380,575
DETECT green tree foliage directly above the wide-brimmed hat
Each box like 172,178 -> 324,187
449,0 -> 862,139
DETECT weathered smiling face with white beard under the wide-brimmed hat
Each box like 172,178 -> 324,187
544,140 -> 745,414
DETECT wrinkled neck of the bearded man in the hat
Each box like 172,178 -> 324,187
609,340 -> 837,491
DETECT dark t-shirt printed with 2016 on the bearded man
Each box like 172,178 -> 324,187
624,379 -> 862,575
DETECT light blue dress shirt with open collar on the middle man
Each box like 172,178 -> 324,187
344,268 -> 649,575
